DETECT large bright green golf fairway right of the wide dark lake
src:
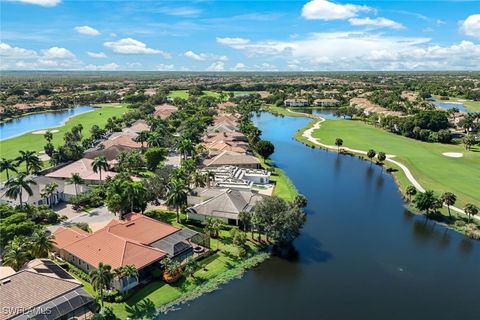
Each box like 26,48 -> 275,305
313,120 -> 480,207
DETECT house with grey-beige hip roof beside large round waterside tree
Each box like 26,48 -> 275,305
186,188 -> 264,224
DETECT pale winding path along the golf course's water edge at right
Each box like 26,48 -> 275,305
286,108 -> 472,220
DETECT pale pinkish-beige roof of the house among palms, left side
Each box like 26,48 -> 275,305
45,158 -> 117,183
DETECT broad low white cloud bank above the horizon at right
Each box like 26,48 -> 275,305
216,32 -> 480,70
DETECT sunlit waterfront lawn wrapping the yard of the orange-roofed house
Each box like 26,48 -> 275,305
104,211 -> 266,319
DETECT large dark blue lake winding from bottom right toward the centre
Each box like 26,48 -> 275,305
162,114 -> 480,320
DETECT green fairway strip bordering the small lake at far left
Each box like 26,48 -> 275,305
0,103 -> 127,180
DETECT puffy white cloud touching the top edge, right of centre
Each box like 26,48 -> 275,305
302,0 -> 374,21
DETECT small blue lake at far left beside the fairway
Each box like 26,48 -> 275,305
0,106 -> 93,140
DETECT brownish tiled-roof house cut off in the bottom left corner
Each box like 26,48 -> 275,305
0,259 -> 95,320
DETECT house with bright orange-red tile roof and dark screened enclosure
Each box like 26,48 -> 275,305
53,213 -> 209,291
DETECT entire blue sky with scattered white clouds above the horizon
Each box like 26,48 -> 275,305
0,0 -> 480,71
